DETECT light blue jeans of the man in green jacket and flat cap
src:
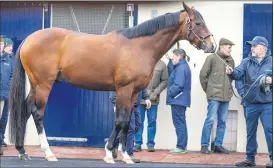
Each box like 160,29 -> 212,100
201,100 -> 229,146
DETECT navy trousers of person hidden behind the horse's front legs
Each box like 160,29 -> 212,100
115,108 -> 140,156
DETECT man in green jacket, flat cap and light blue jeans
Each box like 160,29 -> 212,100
200,38 -> 235,154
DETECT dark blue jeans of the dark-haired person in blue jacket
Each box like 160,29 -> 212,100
171,105 -> 188,150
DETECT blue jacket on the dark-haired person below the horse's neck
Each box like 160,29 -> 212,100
166,59 -> 191,107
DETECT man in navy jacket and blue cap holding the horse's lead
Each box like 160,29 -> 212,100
226,36 -> 273,167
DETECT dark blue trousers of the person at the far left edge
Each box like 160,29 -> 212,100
0,99 -> 9,145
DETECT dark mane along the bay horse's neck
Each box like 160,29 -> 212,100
117,10 -> 184,39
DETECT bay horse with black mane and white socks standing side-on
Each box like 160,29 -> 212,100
9,3 -> 216,163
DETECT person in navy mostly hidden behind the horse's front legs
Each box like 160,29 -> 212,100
109,89 -> 151,163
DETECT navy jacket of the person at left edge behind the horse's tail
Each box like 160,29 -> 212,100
0,53 -> 14,100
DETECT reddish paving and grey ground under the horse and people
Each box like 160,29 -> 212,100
1,146 -> 269,167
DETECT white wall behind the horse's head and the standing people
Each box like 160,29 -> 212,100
138,1 -> 272,152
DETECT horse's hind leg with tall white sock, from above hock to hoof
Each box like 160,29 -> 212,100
29,88 -> 58,161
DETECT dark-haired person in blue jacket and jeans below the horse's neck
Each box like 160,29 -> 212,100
166,49 -> 191,154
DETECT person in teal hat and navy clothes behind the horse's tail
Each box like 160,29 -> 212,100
0,38 -> 14,155
